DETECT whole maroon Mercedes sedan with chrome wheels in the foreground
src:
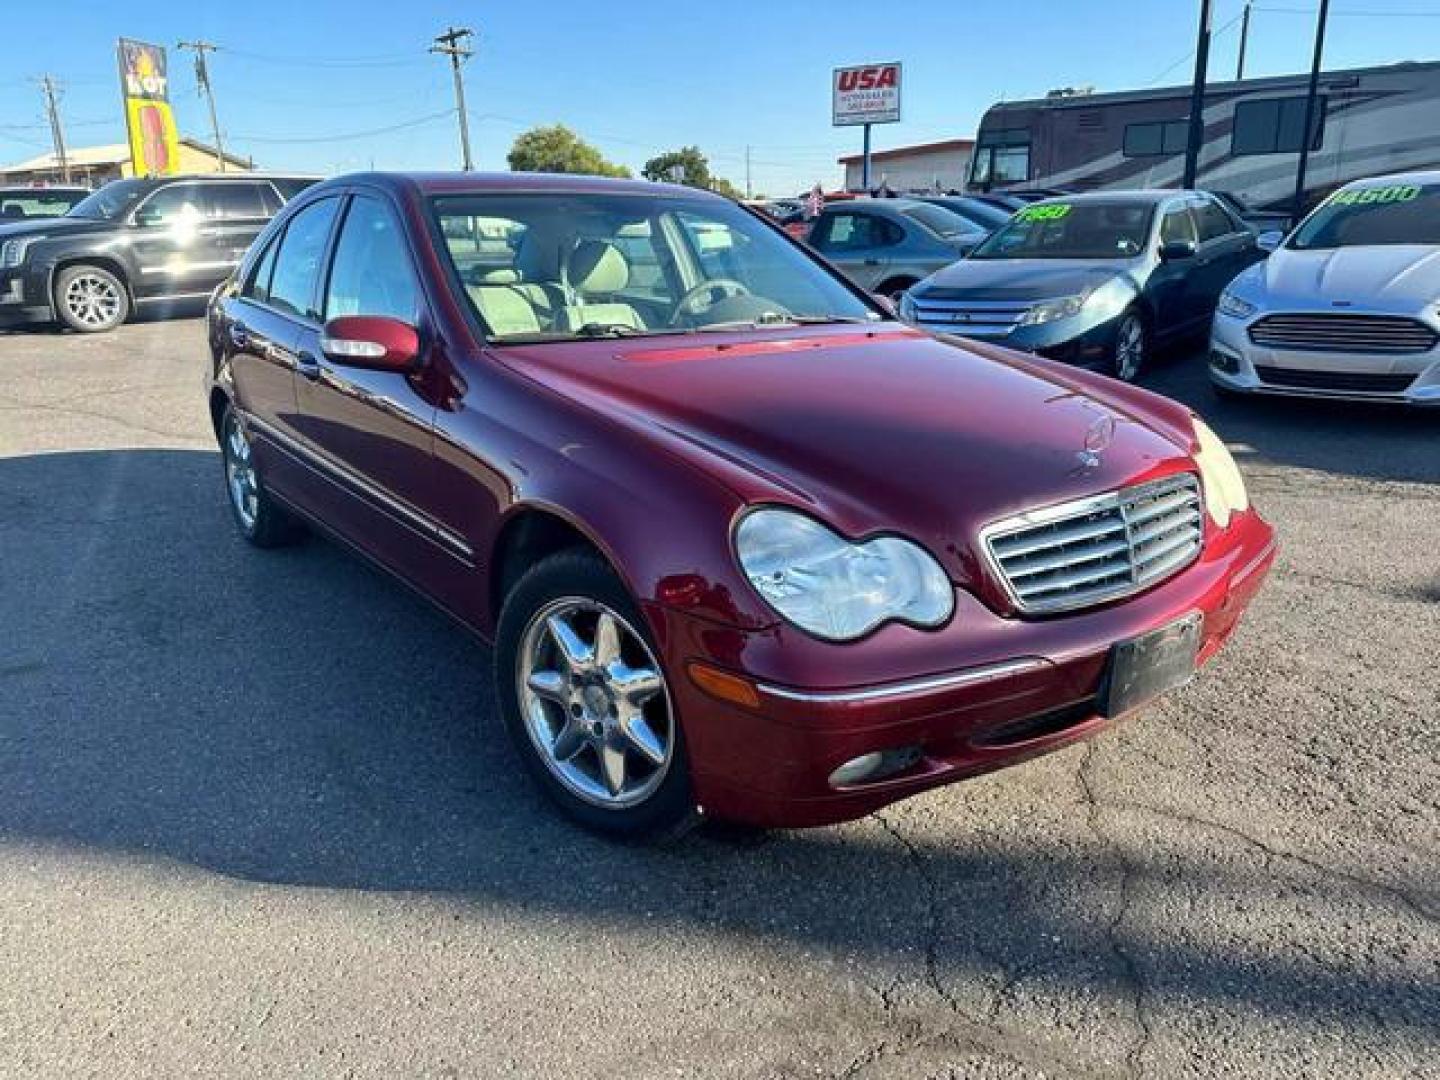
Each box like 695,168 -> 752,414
209,176 -> 1274,835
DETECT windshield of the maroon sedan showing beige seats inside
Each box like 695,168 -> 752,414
432,193 -> 884,341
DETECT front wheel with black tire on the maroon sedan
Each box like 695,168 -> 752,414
495,550 -> 697,840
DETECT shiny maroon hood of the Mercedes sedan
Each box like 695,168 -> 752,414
498,327 -> 1191,575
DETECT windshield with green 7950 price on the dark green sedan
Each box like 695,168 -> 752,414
971,200 -> 1155,259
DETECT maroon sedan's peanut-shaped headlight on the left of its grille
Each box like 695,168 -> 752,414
734,508 -> 955,641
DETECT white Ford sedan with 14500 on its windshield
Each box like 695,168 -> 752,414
1210,171 -> 1440,405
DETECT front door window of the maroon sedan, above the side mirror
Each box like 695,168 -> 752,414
325,194 -> 420,324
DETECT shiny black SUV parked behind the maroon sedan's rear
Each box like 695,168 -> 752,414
0,173 -> 315,333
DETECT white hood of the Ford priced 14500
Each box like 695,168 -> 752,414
1251,243 -> 1440,311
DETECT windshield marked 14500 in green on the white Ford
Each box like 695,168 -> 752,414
1286,184 -> 1440,251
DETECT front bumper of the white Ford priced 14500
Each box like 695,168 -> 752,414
1208,311 -> 1440,406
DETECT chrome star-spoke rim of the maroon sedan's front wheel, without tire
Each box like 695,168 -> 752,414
516,596 -> 675,809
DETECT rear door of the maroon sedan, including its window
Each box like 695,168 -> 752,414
217,197 -> 341,508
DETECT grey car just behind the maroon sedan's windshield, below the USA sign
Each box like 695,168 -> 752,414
806,199 -> 985,300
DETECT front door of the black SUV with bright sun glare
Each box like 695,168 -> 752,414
128,181 -> 235,300
